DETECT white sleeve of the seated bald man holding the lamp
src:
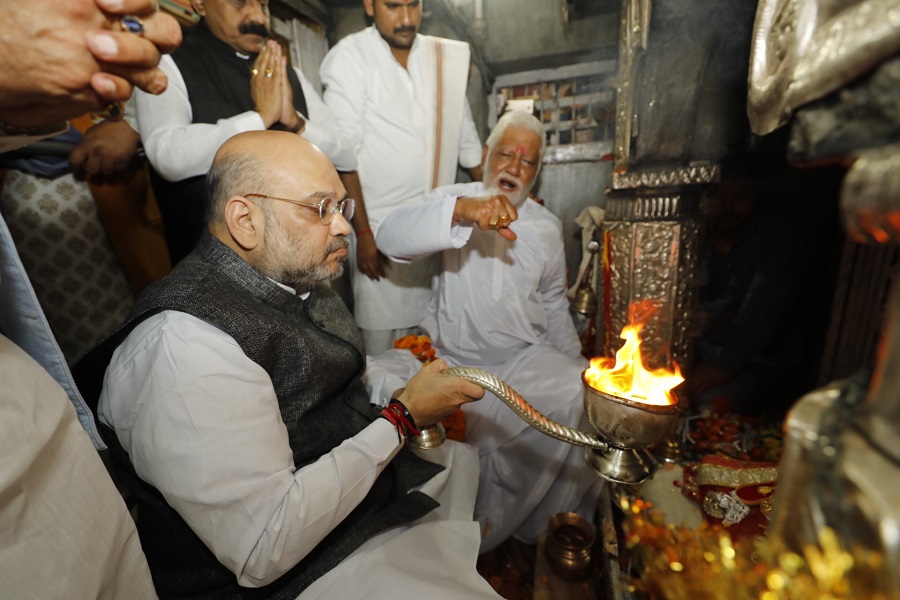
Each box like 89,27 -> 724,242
99,311 -> 400,587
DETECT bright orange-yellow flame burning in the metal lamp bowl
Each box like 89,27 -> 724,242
584,316 -> 684,406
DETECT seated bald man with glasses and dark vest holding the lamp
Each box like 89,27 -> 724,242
76,131 -> 498,600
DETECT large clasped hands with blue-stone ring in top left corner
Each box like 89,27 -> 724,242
0,0 -> 181,129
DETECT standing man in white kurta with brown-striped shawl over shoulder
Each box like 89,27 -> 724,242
320,0 -> 481,354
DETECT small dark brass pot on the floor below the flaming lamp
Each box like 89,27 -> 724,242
544,512 -> 597,580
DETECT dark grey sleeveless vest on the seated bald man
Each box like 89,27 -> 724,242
73,233 -> 443,600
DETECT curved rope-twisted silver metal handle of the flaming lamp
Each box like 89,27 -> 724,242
410,367 -> 609,450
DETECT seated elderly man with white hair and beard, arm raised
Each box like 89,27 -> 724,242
367,112 -> 601,553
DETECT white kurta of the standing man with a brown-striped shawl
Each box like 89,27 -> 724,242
320,26 -> 481,329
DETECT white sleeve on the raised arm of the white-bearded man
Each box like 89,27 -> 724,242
375,182 -> 482,262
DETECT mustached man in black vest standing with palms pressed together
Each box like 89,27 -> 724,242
134,0 -> 363,264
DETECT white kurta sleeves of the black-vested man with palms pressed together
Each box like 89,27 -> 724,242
134,56 -> 356,181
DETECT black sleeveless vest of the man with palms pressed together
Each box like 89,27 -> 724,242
151,20 -> 308,264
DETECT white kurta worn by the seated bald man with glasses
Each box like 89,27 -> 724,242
99,311 -> 497,599
